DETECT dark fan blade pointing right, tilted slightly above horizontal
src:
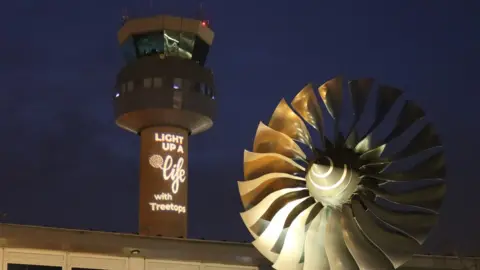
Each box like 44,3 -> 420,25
368,152 -> 447,182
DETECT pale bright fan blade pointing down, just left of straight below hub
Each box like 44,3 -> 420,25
303,208 -> 330,270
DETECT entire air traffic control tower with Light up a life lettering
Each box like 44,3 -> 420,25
113,16 -> 215,237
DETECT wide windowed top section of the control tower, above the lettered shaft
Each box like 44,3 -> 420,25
114,16 -> 215,134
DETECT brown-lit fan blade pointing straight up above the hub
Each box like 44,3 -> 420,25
318,76 -> 343,119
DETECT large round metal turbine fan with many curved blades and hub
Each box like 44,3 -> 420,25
238,77 -> 446,270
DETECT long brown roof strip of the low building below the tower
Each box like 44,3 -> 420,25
0,224 -> 269,266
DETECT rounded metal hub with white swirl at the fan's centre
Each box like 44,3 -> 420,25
306,156 -> 360,207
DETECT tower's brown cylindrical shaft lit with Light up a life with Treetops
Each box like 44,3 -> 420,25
139,126 -> 188,237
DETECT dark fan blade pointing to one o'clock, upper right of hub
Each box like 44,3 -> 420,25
360,85 -> 402,148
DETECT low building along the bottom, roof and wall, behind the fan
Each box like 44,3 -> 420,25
0,224 -> 480,270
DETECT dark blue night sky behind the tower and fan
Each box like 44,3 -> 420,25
0,0 -> 480,255
